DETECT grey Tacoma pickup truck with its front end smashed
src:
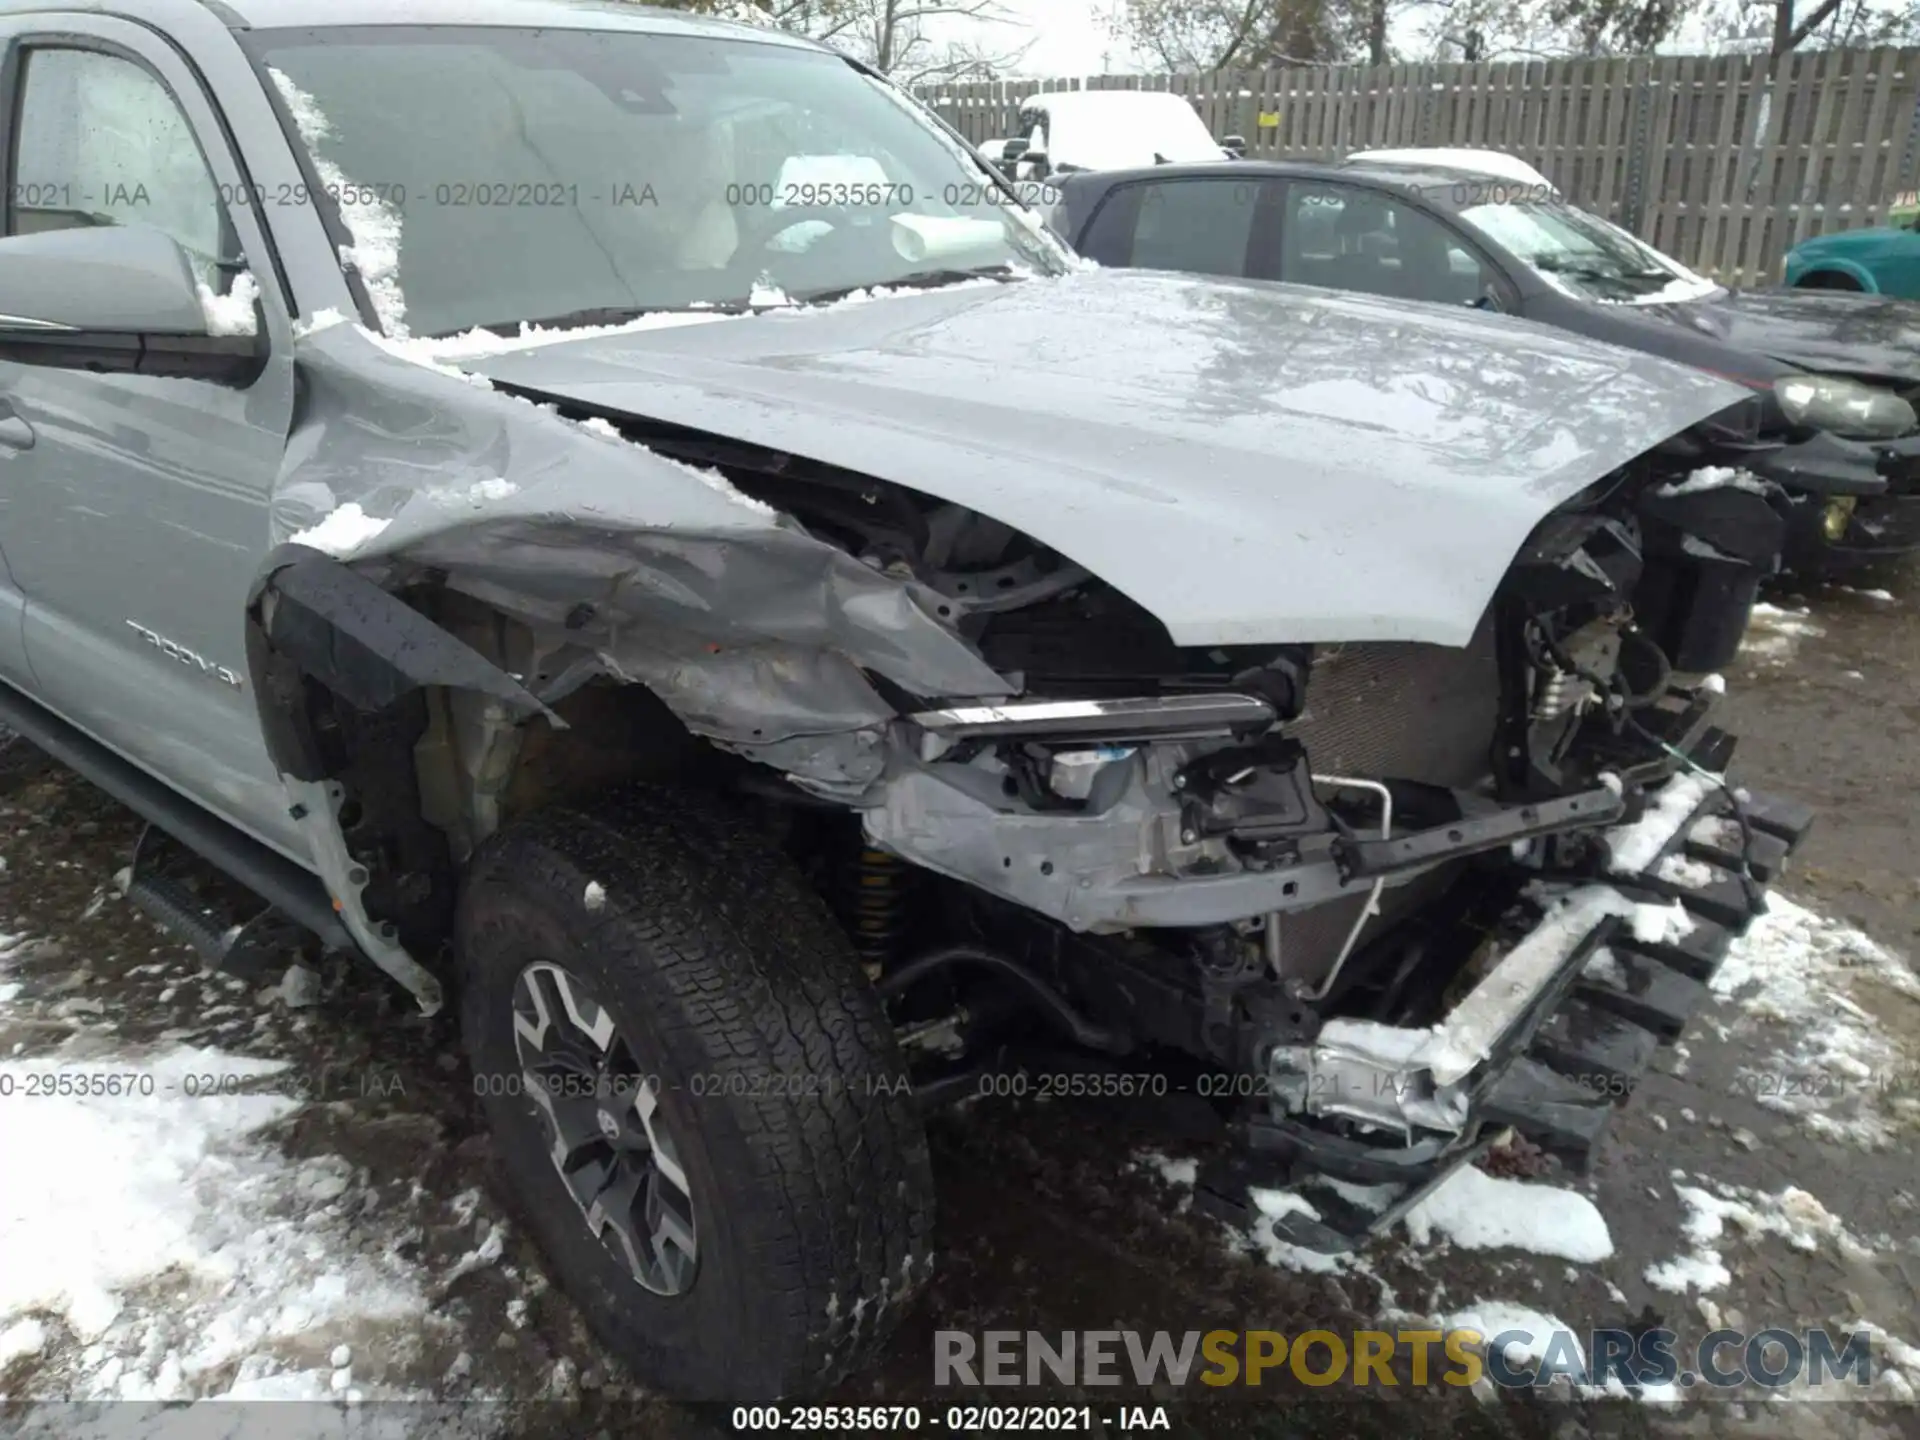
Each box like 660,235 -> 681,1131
0,0 -> 1809,1400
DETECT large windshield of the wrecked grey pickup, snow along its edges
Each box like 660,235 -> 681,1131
246,27 -> 1066,336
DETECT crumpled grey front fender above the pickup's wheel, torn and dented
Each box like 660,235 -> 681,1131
248,324 -> 1036,1010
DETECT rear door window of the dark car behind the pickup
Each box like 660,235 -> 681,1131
1081,179 -> 1267,276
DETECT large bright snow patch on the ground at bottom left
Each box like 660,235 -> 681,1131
0,935 -> 518,1436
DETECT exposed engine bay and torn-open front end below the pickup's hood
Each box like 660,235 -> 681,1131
445,395 -> 1805,1248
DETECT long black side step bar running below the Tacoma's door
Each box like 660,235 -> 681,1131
0,682 -> 355,950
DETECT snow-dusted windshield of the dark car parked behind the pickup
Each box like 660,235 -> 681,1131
1459,200 -> 1718,303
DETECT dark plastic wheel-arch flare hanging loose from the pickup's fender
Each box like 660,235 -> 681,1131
248,545 -> 563,781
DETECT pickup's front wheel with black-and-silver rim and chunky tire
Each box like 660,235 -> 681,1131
455,789 -> 933,1402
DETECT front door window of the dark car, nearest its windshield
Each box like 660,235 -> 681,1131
1273,180 -> 1496,305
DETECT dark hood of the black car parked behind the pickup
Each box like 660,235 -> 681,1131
1651,290 -> 1920,384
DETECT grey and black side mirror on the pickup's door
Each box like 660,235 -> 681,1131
0,225 -> 265,384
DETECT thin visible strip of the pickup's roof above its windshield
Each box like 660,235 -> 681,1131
204,0 -> 824,50
